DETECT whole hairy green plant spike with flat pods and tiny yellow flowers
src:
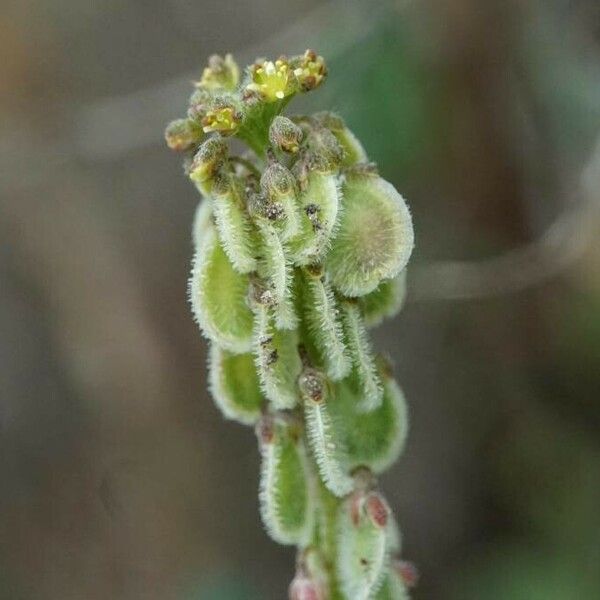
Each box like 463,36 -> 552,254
165,50 -> 415,600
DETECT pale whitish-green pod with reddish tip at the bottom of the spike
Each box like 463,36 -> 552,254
336,492 -> 390,600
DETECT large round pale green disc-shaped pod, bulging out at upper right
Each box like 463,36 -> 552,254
326,173 -> 414,296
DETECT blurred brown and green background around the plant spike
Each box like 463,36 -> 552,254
0,0 -> 600,600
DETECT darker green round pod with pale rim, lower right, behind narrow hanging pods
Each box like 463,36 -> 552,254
329,370 -> 408,473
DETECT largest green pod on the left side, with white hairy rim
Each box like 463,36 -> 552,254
189,228 -> 253,353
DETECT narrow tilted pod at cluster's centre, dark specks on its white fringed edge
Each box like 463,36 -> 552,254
253,302 -> 302,410
